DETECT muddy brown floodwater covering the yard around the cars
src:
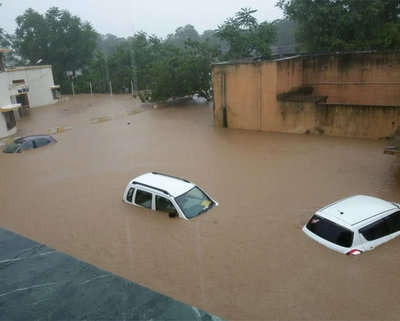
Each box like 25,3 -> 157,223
0,96 -> 400,320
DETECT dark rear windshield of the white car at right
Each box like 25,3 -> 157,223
307,215 -> 354,247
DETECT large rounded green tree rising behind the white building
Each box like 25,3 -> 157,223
15,7 -> 97,81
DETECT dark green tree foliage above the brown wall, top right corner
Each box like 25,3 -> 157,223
277,0 -> 400,51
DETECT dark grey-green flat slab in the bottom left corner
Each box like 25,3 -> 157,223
0,228 -> 222,321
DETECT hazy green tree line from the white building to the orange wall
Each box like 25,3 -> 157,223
7,7 -> 282,100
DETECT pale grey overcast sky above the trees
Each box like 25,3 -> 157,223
0,0 -> 282,38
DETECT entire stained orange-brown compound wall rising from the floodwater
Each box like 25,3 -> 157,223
212,53 -> 400,138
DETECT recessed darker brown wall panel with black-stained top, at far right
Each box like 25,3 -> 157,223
303,53 -> 400,106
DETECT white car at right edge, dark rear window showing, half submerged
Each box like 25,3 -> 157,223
303,195 -> 400,255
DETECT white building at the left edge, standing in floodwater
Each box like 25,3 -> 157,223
0,48 -> 59,138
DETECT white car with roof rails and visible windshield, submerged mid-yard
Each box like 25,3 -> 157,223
122,172 -> 218,220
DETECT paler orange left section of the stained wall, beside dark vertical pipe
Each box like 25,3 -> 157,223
212,62 -> 279,130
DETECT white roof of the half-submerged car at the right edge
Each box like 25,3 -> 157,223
317,195 -> 397,227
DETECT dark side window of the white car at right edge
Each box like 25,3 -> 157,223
360,212 -> 400,241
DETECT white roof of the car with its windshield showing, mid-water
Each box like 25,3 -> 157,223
132,172 -> 195,197
